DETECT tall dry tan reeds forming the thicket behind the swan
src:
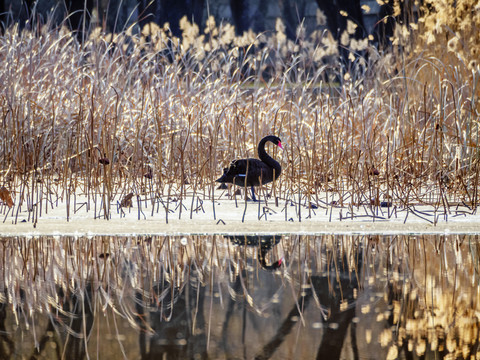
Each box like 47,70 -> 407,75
0,0 -> 480,219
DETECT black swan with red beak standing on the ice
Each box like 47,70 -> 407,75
216,135 -> 283,201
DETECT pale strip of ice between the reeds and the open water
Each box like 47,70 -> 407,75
0,191 -> 480,236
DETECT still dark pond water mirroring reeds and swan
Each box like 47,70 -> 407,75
0,235 -> 480,360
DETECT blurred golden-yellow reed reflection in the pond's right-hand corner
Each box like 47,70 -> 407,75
387,236 -> 480,359
